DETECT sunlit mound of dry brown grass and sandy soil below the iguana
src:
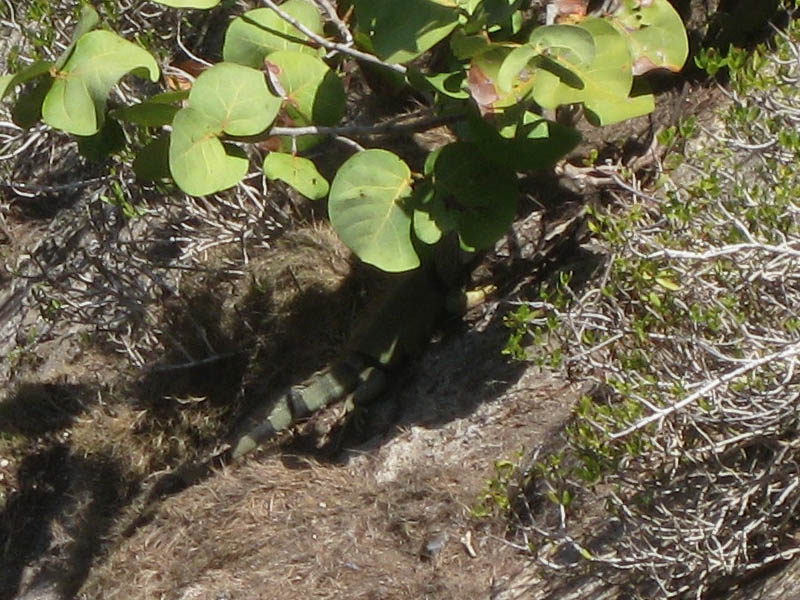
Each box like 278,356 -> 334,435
81,370 -> 563,599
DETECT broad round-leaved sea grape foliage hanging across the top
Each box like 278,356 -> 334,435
0,0 -> 688,271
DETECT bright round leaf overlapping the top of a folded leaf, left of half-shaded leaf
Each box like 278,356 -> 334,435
189,62 -> 281,136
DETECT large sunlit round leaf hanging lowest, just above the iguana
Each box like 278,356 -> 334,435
328,150 -> 419,272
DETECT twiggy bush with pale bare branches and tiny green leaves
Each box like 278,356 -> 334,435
505,15 -> 800,596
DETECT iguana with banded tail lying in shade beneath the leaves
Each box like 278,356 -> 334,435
228,209 -> 584,460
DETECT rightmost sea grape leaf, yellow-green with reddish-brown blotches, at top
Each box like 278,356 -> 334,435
611,0 -> 689,75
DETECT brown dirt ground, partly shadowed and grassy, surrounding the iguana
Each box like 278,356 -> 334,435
0,2 -> 796,600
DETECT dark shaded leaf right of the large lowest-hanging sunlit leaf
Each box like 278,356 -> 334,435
433,142 -> 519,249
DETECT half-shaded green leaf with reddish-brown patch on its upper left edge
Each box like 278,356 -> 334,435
266,50 -> 345,150
